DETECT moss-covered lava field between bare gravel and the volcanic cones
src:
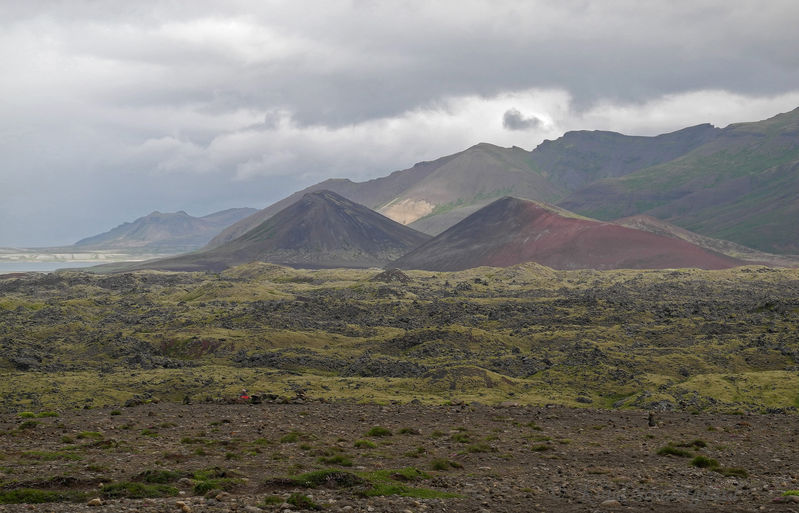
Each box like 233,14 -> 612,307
0,264 -> 799,411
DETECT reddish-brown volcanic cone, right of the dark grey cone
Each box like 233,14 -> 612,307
393,197 -> 741,271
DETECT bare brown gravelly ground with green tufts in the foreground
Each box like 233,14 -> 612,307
0,402 -> 799,513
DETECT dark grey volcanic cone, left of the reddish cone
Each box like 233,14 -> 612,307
135,191 -> 430,271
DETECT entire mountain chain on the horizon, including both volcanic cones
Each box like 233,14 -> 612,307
78,109 -> 799,271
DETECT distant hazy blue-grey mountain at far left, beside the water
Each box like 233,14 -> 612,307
74,208 -> 257,253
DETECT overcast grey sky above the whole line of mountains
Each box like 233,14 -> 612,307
0,0 -> 799,246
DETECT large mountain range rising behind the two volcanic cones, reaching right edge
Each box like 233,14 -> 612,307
209,109 -> 799,254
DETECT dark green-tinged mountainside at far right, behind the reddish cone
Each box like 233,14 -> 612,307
560,109 -> 799,253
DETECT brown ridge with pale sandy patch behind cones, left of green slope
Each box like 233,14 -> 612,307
208,124 -> 719,248
